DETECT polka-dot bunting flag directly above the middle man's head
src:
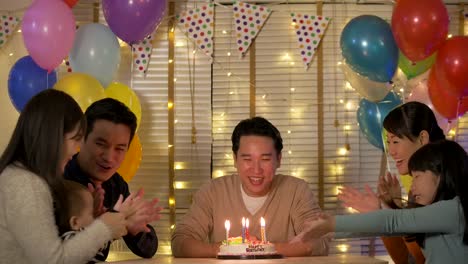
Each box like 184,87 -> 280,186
233,1 -> 271,56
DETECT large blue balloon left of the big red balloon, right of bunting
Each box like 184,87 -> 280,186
340,15 -> 398,82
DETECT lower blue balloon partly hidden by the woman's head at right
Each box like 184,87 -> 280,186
357,92 -> 402,151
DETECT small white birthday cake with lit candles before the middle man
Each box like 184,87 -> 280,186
218,236 -> 282,258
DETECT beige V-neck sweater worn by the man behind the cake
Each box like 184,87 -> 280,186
172,175 -> 328,255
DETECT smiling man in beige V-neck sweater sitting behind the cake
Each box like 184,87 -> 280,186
171,117 -> 328,257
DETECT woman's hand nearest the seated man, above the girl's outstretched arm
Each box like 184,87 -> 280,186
338,184 -> 380,213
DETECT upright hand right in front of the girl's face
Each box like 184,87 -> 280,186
378,172 -> 401,208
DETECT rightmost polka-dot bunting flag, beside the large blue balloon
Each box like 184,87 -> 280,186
291,13 -> 330,69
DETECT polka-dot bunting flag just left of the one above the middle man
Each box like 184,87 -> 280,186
177,3 -> 214,58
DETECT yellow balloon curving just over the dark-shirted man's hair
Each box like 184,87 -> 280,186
105,82 -> 141,130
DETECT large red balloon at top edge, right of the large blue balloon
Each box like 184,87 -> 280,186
392,0 -> 449,61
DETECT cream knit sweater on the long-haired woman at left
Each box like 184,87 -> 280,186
0,165 -> 112,264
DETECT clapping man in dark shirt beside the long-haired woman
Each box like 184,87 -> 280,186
65,98 -> 161,260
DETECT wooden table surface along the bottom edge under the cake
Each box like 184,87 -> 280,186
112,255 -> 388,264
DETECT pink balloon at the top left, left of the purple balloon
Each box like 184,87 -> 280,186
21,0 -> 75,71
